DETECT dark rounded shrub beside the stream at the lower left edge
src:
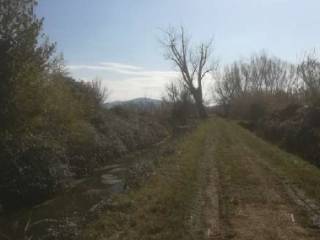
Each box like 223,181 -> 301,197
0,136 -> 68,209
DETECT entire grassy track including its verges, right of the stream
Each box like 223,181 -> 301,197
82,118 -> 320,240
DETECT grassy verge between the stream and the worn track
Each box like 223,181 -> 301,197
83,121 -> 210,240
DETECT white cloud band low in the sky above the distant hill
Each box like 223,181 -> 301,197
67,62 -> 179,101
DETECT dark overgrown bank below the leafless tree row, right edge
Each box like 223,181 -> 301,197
242,104 -> 320,167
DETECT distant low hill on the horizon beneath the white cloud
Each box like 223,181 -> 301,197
105,98 -> 161,110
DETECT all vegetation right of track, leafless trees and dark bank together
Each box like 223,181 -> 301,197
214,53 -> 320,166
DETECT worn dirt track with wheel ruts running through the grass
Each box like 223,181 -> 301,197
202,120 -> 320,240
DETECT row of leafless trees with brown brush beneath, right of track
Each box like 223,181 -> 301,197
214,53 -> 320,120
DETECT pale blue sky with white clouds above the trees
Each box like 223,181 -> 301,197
38,0 -> 320,100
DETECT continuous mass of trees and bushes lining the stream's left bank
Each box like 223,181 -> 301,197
0,0 -> 167,210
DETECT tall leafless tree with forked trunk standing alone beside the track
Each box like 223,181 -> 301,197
162,27 -> 214,118
